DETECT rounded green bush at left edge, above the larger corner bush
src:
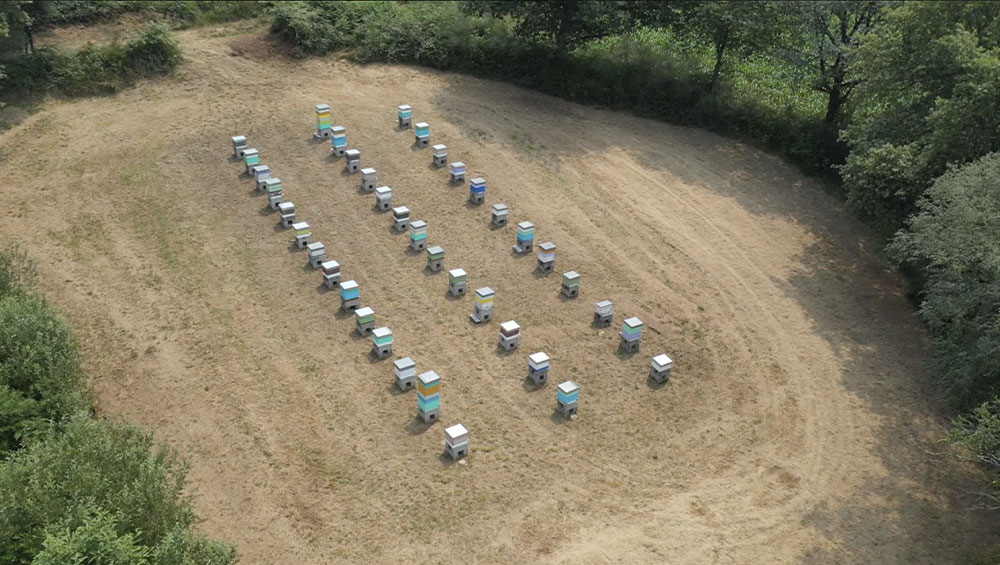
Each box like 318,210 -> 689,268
0,294 -> 88,455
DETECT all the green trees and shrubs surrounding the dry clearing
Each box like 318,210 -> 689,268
0,0 -> 1000,563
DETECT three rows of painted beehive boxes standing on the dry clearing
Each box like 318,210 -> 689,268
225,104 -> 673,459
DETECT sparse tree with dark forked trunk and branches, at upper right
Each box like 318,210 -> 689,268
795,0 -> 884,125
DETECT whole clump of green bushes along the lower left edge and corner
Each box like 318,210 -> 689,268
0,246 -> 236,565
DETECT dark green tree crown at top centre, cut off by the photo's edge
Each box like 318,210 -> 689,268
464,0 -> 631,55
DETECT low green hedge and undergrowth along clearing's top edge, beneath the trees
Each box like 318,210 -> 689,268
270,2 -> 842,170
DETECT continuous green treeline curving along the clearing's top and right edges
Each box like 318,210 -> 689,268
269,0 -> 1000,498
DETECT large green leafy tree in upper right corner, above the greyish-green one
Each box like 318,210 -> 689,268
842,2 -> 1000,232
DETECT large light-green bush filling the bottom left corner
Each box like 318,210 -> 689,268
0,417 -> 235,565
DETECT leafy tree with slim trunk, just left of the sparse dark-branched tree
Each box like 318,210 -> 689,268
677,1 -> 790,94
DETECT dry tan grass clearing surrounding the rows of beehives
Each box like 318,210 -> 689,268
0,24 -> 996,564
